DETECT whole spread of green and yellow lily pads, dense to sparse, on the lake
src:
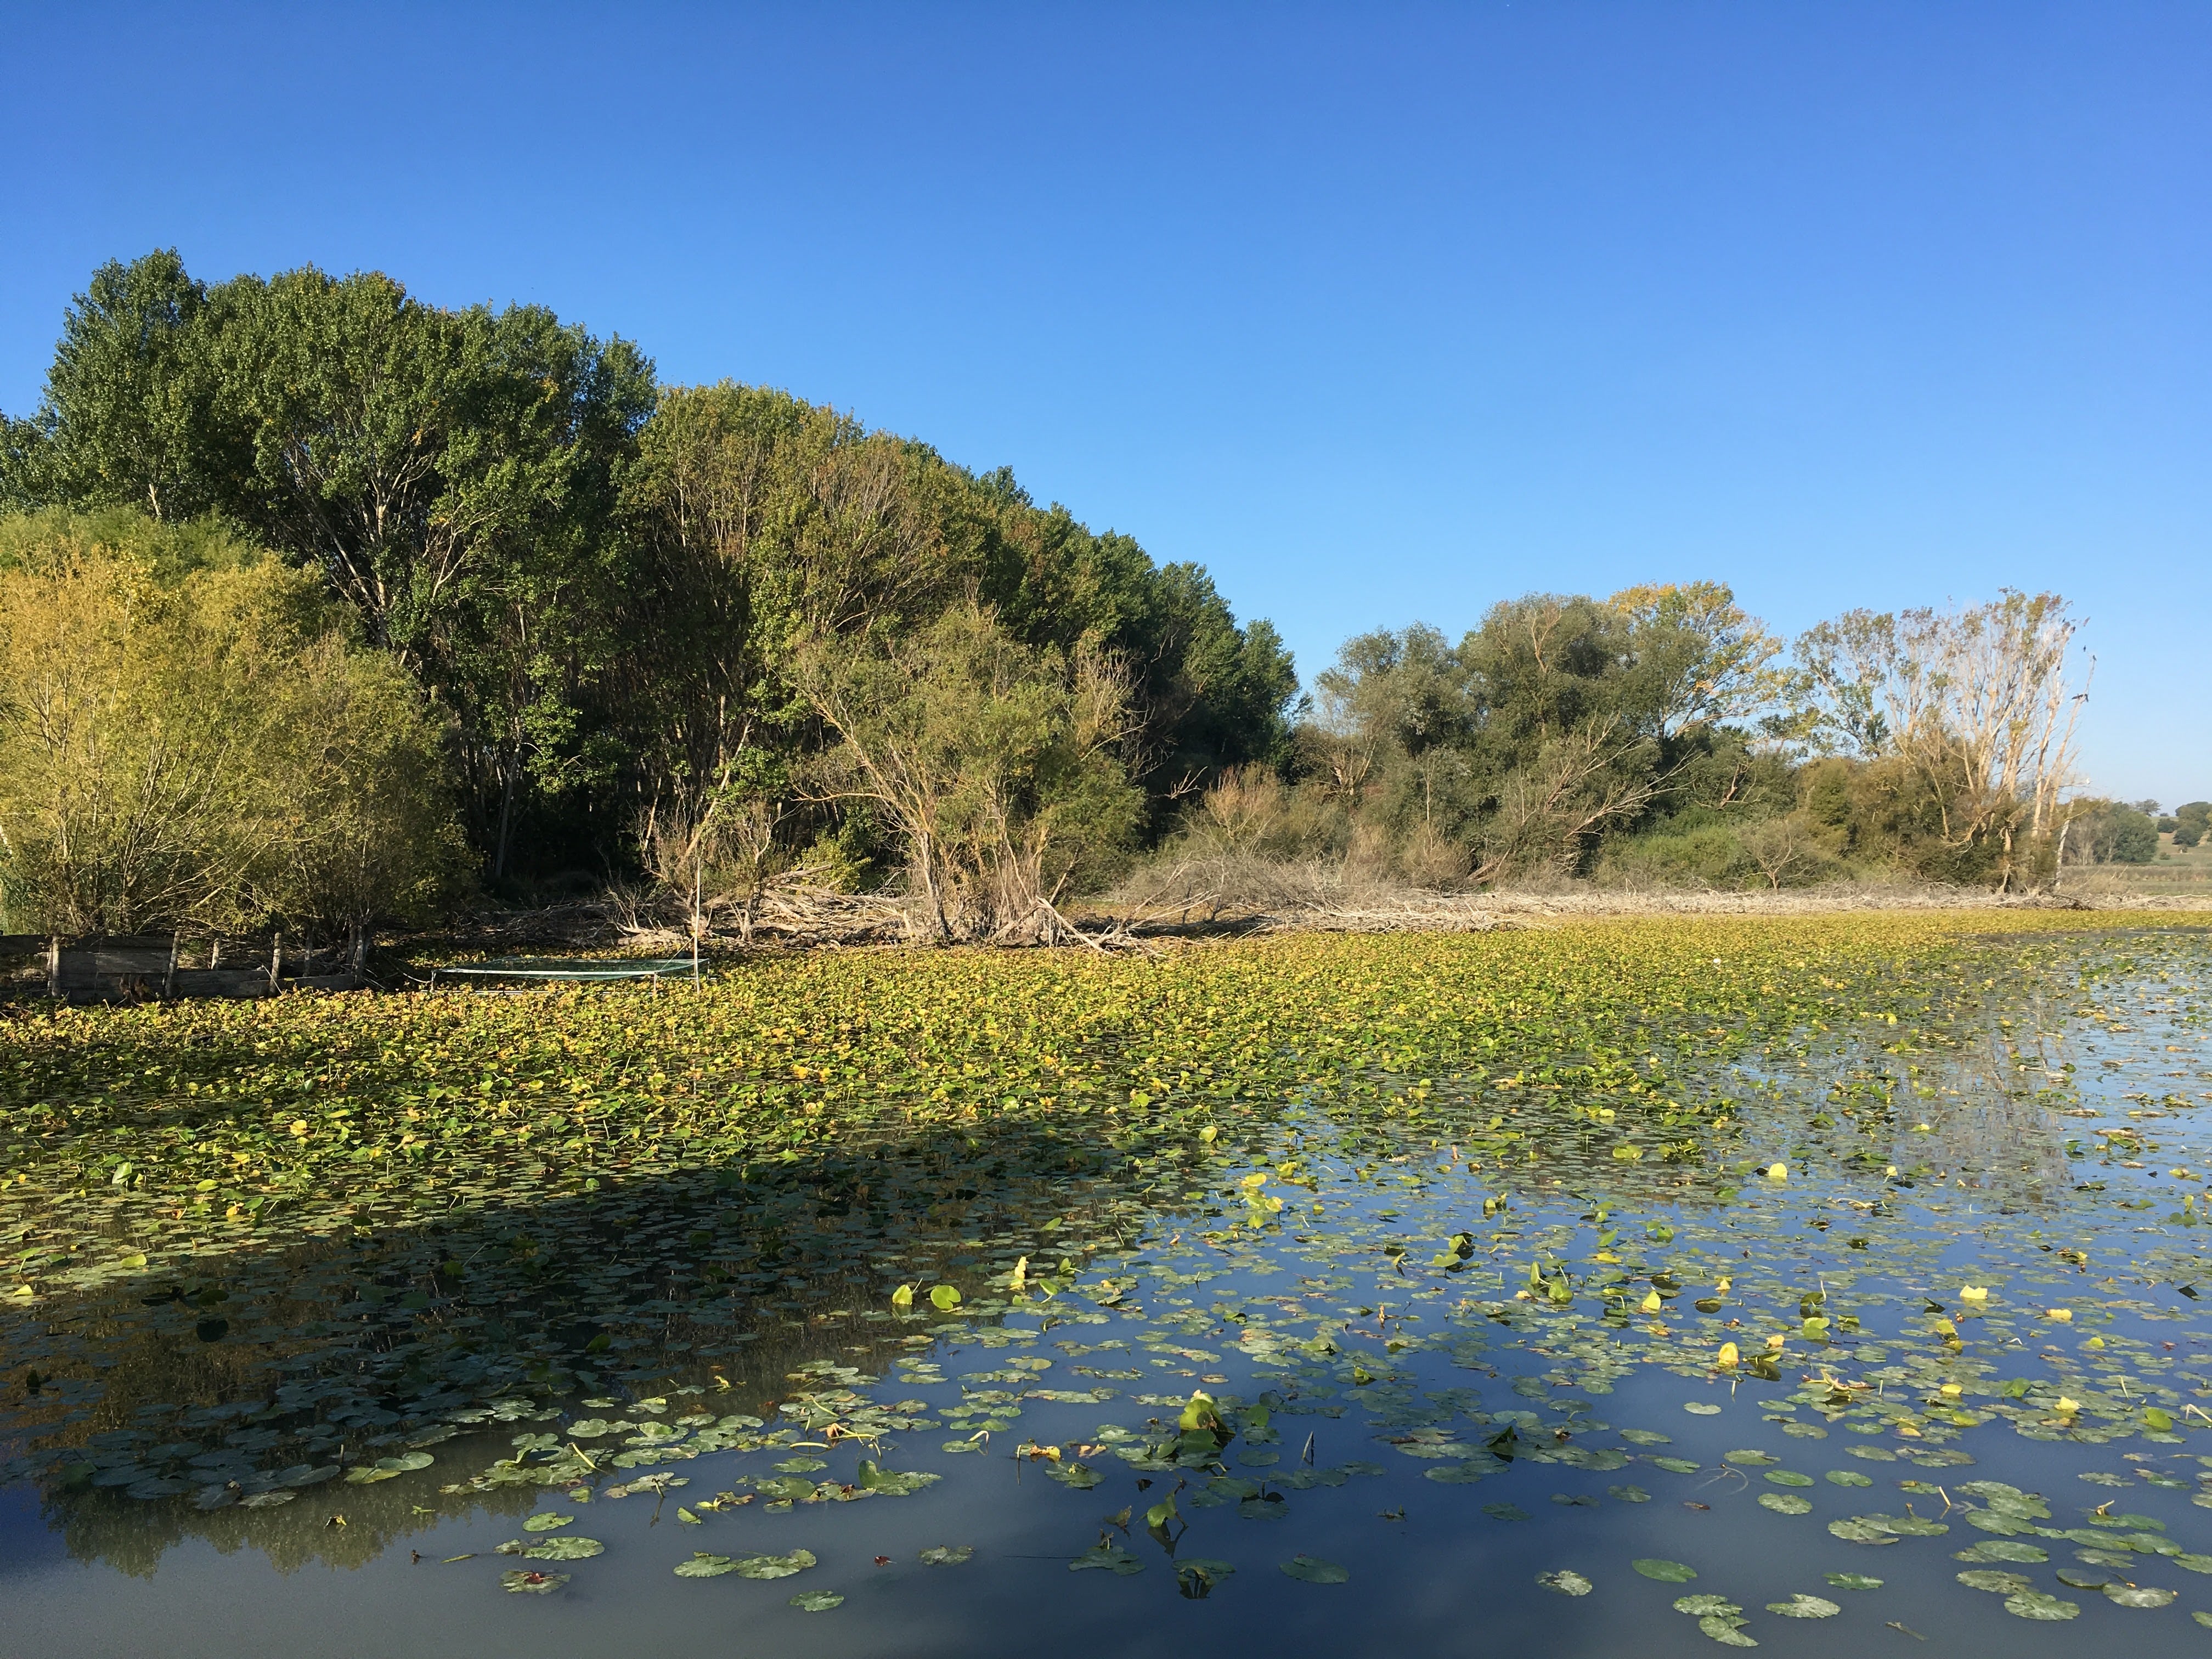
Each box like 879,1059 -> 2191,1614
13,916 -> 2212,1646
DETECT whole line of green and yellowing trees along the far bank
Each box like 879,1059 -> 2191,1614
0,252 -> 2081,938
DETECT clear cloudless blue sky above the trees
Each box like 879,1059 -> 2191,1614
0,0 -> 2212,805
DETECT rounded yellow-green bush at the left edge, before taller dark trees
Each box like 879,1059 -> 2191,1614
0,513 -> 460,936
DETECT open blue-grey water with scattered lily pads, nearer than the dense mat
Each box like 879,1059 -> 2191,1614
0,934 -> 2212,1659
